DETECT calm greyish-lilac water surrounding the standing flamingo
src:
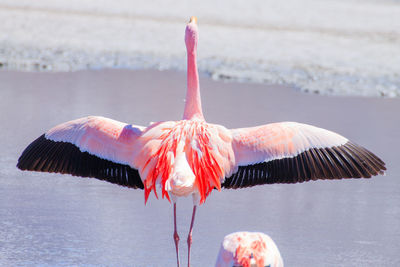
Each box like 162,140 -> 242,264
0,70 -> 400,267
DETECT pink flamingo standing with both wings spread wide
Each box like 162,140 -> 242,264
17,17 -> 386,266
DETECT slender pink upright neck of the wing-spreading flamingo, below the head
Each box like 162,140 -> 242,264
183,50 -> 204,120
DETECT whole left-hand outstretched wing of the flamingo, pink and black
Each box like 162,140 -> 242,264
17,116 -> 144,189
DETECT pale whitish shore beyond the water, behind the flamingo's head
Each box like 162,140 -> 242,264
0,0 -> 400,97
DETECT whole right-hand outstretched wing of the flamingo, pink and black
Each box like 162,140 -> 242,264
222,122 -> 386,188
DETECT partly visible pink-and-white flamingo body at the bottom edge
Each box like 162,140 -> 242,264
215,232 -> 283,267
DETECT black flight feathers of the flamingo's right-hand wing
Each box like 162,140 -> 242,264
222,142 -> 386,188
